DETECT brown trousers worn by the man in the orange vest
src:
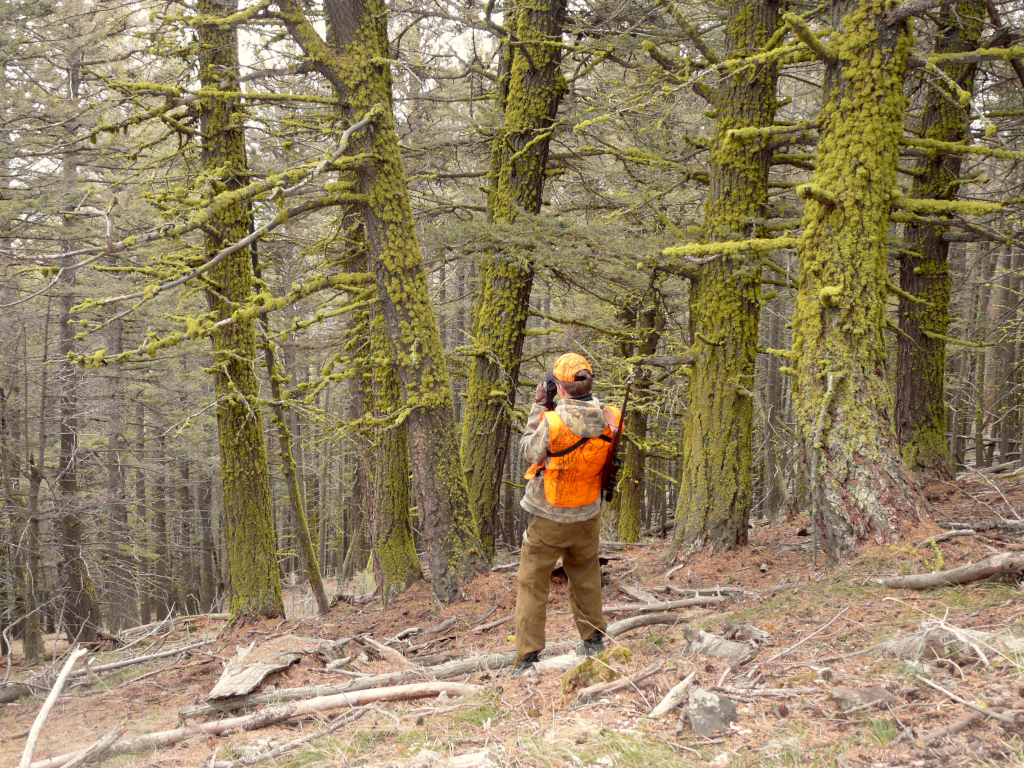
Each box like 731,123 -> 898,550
515,515 -> 607,658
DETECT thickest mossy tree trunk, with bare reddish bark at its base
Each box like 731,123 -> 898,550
793,0 -> 921,561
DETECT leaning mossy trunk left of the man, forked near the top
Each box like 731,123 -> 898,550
279,0 -> 485,601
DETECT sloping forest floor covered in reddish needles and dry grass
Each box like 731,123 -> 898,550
0,477 -> 1024,768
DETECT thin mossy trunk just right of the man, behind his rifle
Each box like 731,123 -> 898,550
615,294 -> 666,543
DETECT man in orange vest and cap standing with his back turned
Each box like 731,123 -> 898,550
513,352 -> 620,675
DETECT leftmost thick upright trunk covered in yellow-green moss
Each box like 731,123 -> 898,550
198,0 -> 285,621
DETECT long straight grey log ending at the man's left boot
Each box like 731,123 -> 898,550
178,651 -> 515,720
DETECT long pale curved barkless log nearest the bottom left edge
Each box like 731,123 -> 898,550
31,683 -> 480,768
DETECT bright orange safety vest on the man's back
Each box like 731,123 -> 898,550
526,406 -> 621,507
